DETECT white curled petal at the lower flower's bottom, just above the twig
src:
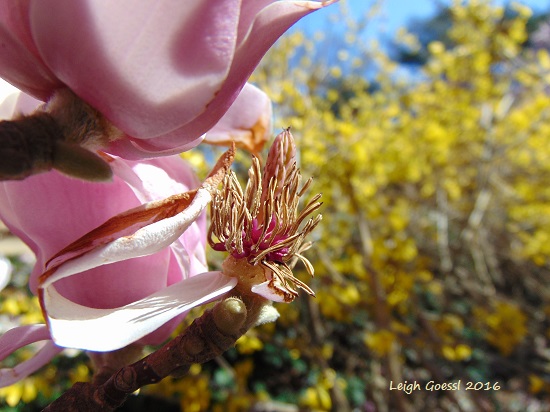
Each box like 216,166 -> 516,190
41,272 -> 237,352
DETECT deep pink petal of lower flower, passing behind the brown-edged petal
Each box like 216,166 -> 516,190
0,165 -> 179,307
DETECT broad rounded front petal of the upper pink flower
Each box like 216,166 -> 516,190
29,0 -> 244,138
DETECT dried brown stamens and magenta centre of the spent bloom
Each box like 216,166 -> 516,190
208,129 -> 321,302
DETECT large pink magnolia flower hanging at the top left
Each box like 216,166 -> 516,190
0,0 -> 335,159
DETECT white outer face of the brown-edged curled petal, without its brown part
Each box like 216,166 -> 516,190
39,189 -> 212,288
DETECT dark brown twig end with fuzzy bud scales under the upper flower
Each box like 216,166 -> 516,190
0,89 -> 120,181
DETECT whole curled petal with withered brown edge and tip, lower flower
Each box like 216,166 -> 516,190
39,145 -> 235,287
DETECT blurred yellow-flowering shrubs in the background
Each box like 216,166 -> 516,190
0,0 -> 550,412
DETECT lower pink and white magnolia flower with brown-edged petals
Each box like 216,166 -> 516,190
0,96 -> 236,386
